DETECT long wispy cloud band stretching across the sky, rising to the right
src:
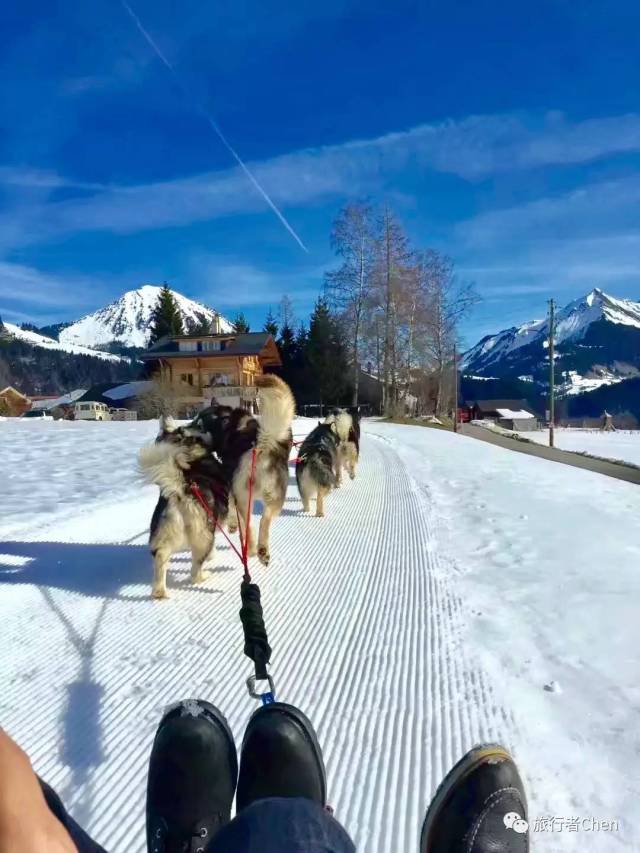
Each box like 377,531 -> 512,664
5,108 -> 640,244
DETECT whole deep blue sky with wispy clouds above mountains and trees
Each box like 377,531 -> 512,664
0,0 -> 640,344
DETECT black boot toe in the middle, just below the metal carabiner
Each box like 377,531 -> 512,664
236,702 -> 327,812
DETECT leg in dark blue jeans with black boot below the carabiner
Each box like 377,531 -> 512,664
210,702 -> 355,853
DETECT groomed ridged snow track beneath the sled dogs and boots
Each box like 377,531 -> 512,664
0,422 -> 515,853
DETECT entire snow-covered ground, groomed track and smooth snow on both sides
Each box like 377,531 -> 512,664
0,421 -> 640,853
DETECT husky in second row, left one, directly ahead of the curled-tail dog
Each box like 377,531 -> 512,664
296,422 -> 338,518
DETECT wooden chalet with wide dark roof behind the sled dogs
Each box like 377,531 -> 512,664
140,332 -> 282,414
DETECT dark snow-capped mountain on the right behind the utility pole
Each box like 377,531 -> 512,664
462,288 -> 640,394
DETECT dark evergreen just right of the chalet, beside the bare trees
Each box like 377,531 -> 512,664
305,297 -> 347,407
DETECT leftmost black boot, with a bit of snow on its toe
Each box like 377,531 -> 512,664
147,699 -> 238,853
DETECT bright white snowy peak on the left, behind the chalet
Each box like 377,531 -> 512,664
60,284 -> 231,348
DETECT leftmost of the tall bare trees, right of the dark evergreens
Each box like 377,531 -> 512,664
325,203 -> 376,406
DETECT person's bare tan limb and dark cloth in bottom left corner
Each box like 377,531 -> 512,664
0,729 -> 104,853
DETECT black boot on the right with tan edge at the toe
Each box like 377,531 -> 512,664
420,744 -> 529,853
